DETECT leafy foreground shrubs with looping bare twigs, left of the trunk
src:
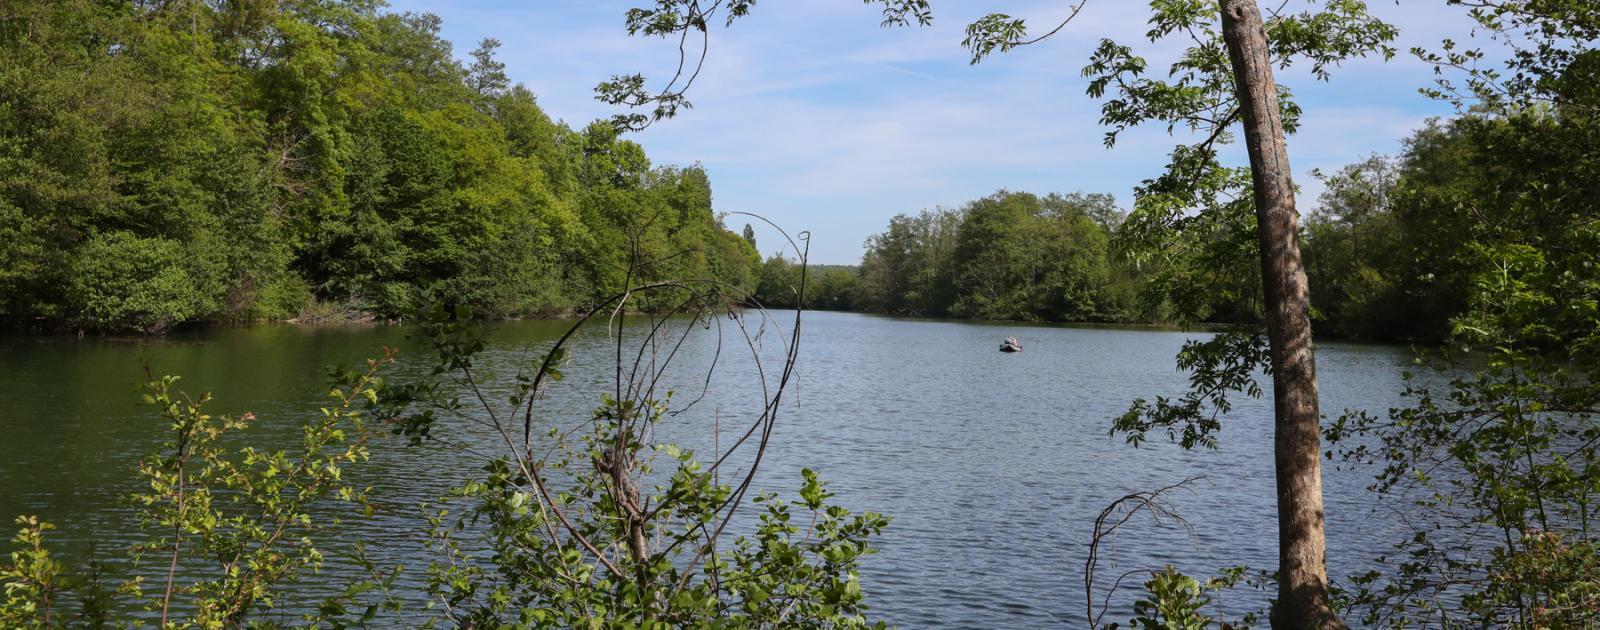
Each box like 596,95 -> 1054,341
0,297 -> 888,628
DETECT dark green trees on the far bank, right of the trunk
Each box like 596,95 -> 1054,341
1306,109 -> 1600,341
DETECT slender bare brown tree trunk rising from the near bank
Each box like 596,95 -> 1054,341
1221,0 -> 1344,630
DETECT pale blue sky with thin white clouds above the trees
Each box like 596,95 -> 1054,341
380,0 -> 1472,264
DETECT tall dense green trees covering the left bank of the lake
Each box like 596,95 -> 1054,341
0,0 -> 758,331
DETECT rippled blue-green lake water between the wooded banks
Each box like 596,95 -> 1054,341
0,312 -> 1411,627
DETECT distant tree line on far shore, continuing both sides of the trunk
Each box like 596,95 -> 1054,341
757,99 -> 1600,350
